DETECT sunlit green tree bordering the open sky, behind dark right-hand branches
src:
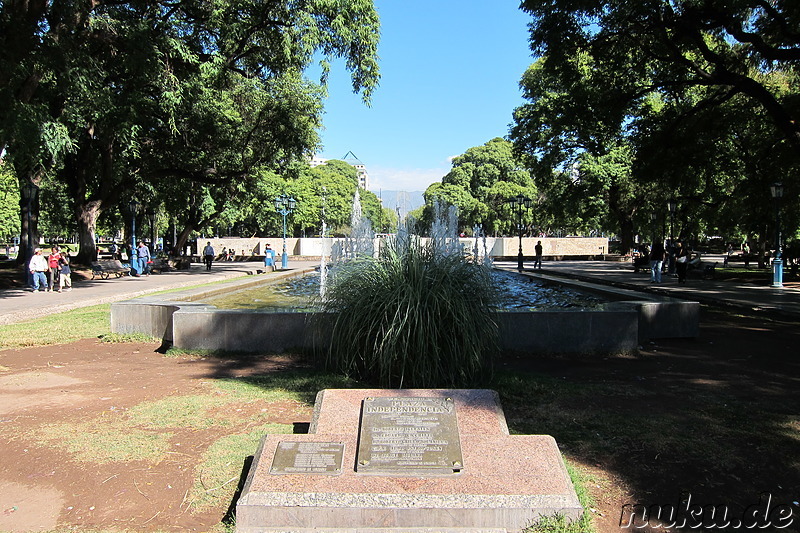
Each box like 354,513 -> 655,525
511,53 -> 649,253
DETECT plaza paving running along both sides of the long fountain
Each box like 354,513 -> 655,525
0,258 -> 800,324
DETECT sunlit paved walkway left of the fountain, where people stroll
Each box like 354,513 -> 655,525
0,261 -> 319,325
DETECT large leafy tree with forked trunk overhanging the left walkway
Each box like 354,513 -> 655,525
0,0 -> 378,259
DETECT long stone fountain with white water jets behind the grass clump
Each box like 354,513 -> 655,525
111,197 -> 699,354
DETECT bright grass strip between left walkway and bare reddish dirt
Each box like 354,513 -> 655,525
0,304 -> 111,349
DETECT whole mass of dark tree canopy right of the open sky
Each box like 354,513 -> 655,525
511,0 -> 800,251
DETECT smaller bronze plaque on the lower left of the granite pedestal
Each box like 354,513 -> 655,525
269,441 -> 344,475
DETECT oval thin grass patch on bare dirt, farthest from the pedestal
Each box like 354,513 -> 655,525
34,417 -> 172,464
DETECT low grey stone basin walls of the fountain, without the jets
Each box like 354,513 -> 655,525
111,272 -> 700,356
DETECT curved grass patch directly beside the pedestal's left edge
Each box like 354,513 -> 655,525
189,424 -> 293,512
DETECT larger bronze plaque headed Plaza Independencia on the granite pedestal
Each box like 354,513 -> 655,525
356,397 -> 463,476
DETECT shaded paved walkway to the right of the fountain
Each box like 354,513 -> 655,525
498,256 -> 800,319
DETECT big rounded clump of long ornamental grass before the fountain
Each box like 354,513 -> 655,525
320,237 -> 497,388
